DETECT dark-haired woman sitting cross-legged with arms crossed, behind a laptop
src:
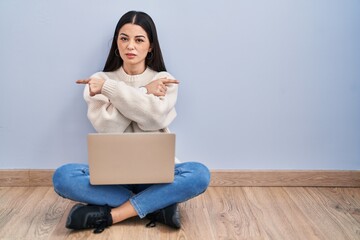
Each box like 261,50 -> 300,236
53,11 -> 210,233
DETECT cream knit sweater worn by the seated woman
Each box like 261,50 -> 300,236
84,67 -> 178,133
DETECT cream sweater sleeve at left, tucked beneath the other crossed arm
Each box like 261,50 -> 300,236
84,75 -> 131,133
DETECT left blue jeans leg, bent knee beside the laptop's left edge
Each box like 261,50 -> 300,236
53,163 -> 133,207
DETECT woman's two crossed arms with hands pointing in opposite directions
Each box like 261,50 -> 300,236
77,75 -> 179,132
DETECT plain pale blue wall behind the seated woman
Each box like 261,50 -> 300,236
0,0 -> 360,169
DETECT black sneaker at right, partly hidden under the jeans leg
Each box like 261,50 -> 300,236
146,203 -> 180,229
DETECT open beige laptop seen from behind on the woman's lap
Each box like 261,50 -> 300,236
88,132 -> 175,185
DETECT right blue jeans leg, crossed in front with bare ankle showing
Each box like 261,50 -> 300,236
130,162 -> 210,218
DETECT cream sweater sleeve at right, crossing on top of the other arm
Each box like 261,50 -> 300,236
102,72 -> 178,131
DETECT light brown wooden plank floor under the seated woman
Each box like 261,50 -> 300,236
0,187 -> 360,240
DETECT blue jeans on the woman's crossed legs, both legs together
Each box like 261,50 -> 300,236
53,162 -> 210,218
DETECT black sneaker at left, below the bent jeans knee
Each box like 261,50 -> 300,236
66,203 -> 112,233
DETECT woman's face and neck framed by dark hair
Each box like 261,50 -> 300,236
117,23 -> 151,72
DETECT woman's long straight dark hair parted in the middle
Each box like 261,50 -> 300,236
103,11 -> 166,72
